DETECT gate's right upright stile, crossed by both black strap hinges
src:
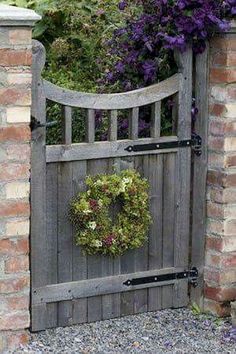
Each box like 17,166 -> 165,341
174,48 -> 193,307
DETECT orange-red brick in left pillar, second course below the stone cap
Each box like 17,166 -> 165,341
0,48 -> 32,66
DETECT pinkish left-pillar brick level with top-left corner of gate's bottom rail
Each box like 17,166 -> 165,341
0,276 -> 30,294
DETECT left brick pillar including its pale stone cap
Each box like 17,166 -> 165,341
0,5 -> 40,353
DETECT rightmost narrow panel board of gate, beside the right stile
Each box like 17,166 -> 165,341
162,153 -> 176,308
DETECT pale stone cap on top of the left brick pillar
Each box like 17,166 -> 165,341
0,5 -> 41,27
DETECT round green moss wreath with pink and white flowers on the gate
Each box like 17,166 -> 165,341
70,170 -> 151,256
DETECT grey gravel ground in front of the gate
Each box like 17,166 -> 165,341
15,309 -> 236,354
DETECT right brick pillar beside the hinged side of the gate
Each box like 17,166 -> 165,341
205,23 -> 236,316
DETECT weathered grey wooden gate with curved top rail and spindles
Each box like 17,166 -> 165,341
31,43 -> 192,331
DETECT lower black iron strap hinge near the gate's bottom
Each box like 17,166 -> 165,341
123,267 -> 198,288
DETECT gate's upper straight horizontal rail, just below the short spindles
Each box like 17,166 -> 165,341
46,136 -> 178,162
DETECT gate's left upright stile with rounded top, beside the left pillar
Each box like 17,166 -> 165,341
30,41 -> 48,331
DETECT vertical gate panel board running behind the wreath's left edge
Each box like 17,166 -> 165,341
72,161 -> 88,324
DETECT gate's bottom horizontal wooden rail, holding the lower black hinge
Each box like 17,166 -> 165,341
32,268 -> 188,305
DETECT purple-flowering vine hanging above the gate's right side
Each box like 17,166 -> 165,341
106,0 -> 236,90
